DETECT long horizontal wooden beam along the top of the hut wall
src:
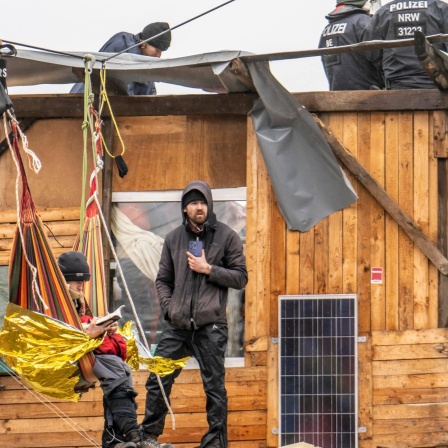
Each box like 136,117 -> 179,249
11,89 -> 448,119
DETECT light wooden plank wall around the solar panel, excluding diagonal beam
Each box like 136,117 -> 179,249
246,107 -> 448,448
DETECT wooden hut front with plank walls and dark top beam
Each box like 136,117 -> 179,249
0,40 -> 448,448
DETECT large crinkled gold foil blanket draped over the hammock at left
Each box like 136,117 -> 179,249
0,303 -> 102,402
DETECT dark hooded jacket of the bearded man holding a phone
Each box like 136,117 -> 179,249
156,181 -> 247,329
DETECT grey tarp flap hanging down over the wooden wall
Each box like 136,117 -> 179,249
247,62 -> 357,232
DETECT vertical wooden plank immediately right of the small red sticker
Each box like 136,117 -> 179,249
384,112 -> 400,330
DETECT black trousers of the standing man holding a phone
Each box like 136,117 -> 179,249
142,323 -> 227,448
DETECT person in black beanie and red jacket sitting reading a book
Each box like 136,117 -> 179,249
58,251 -> 153,448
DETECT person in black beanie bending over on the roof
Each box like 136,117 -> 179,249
70,22 -> 171,96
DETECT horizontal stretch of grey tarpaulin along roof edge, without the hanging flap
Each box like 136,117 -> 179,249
3,49 -> 251,93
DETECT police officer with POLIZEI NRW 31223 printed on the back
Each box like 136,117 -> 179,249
363,0 -> 448,89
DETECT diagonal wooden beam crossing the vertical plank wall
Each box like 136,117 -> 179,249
315,117 -> 448,275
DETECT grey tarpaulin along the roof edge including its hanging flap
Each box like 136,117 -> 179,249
0,45 -> 356,231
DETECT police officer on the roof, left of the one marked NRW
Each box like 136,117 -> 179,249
319,0 -> 384,90
